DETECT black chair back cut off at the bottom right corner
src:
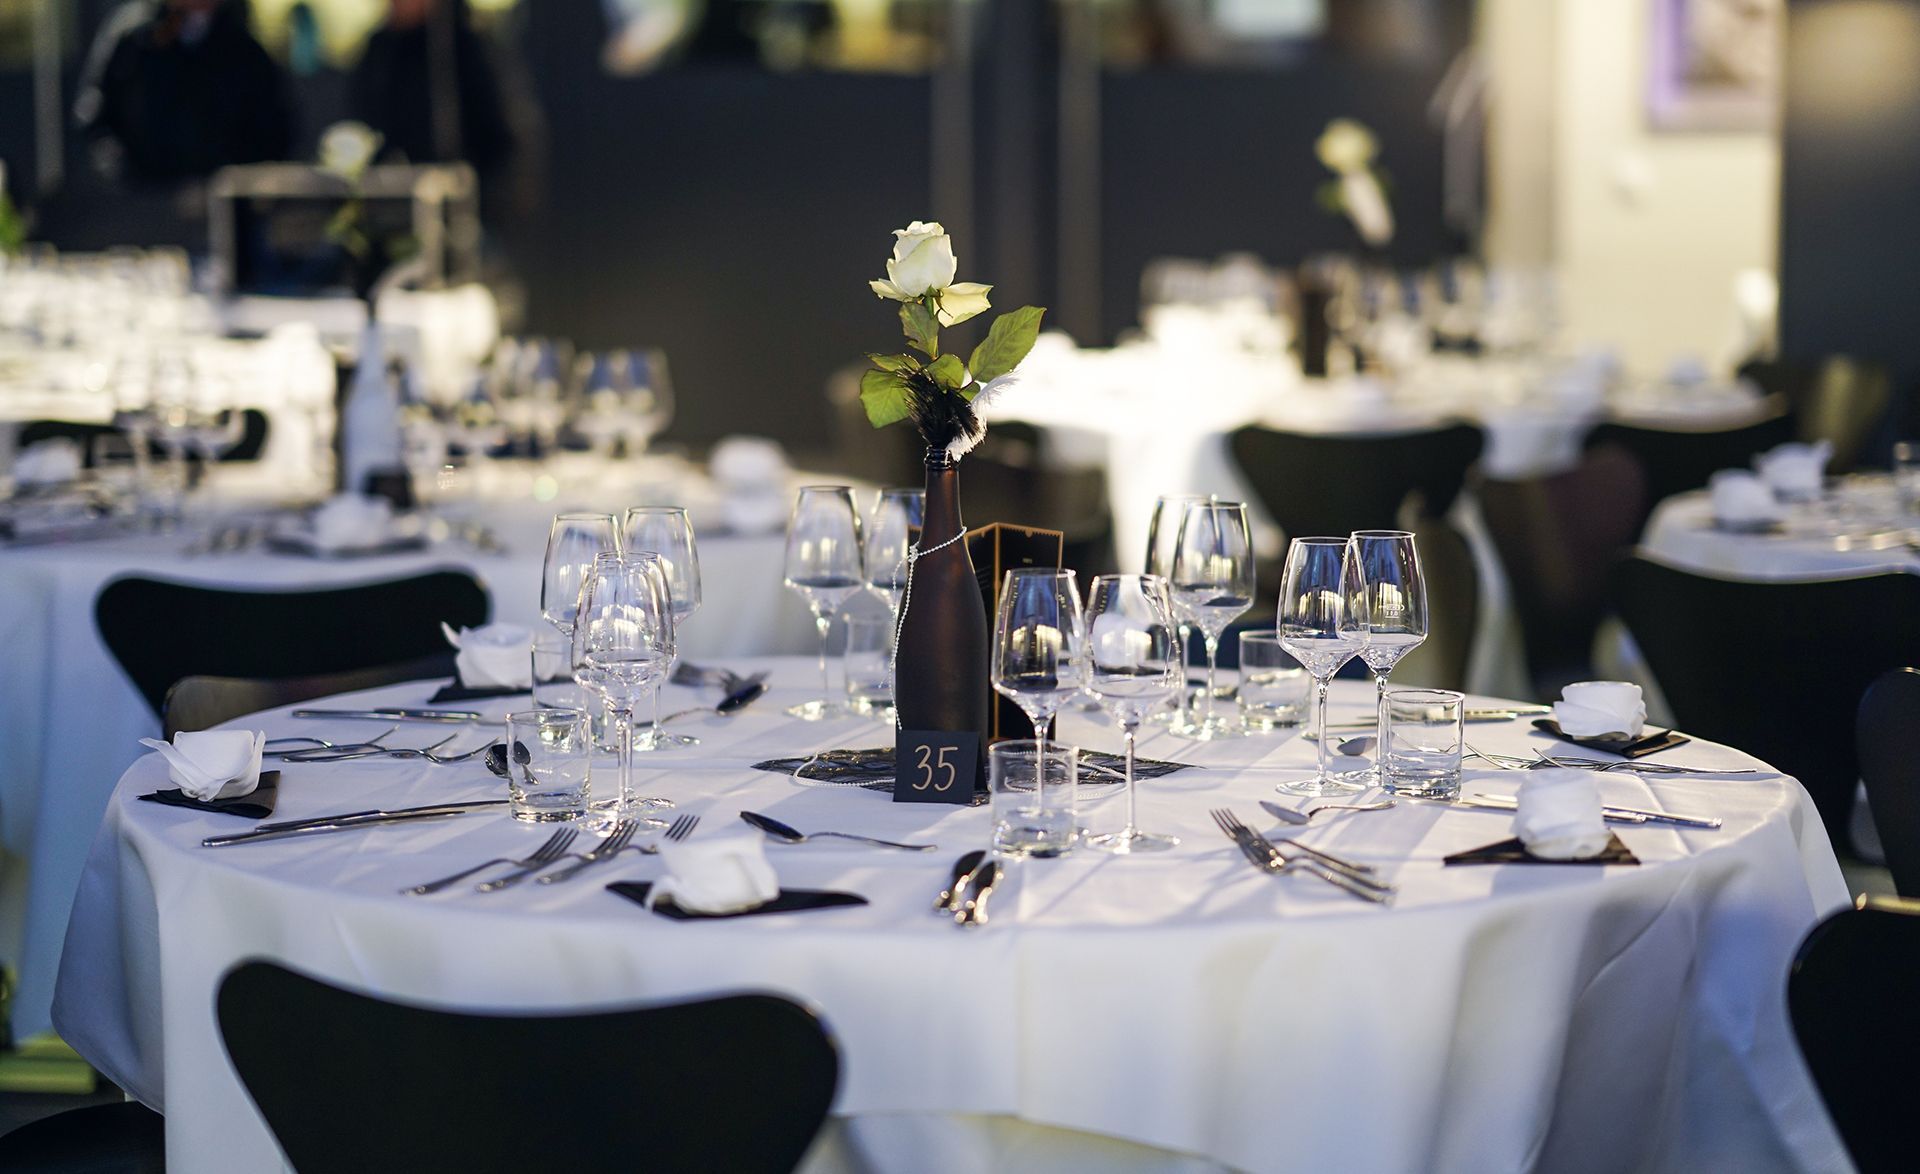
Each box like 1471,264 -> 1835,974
1788,901 -> 1920,1174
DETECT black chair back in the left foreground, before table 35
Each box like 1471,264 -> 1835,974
217,961 -> 839,1174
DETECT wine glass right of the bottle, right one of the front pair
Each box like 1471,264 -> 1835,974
1087,575 -> 1187,853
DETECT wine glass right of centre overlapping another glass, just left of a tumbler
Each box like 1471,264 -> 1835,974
1169,501 -> 1254,742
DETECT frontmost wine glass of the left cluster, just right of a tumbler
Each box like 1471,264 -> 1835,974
572,553 -> 674,819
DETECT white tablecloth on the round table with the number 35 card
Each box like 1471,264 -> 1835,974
56,659 -> 1847,1172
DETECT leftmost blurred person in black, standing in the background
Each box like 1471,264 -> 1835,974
75,0 -> 294,186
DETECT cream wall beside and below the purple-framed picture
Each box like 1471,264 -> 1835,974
1482,0 -> 1780,371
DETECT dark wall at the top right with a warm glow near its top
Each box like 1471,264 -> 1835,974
1780,0 -> 1920,403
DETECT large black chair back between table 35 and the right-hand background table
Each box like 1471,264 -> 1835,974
1613,557 -> 1920,845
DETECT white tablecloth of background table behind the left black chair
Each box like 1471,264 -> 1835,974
0,466 -> 816,1036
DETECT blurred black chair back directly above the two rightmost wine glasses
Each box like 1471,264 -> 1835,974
1227,425 -> 1486,538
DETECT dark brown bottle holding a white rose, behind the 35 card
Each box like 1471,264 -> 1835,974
893,450 -> 989,765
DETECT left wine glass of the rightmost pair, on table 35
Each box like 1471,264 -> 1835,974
1275,538 -> 1367,797
